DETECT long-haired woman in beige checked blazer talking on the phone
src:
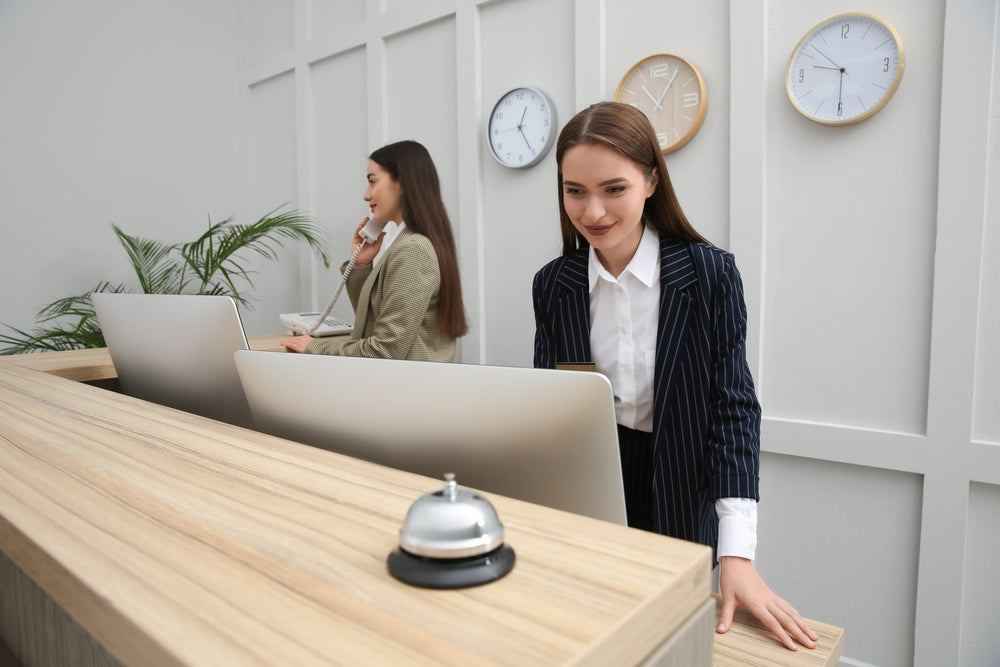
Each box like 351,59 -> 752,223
282,141 -> 469,361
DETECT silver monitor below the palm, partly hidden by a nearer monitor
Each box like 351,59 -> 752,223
91,292 -> 253,428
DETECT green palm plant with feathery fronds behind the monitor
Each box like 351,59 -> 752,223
0,207 -> 330,355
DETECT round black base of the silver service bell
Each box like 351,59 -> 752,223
388,545 -> 514,588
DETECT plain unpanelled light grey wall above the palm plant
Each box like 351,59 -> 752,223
0,0 -> 249,332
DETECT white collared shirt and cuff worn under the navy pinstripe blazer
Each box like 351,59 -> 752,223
588,226 -> 757,560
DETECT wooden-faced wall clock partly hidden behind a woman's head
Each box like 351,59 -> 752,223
615,53 -> 708,153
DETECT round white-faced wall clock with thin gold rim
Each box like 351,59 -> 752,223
785,14 -> 903,125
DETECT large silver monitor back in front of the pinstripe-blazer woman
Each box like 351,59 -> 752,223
234,351 -> 626,525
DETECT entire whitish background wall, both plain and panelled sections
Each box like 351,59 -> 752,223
0,0 -> 1000,666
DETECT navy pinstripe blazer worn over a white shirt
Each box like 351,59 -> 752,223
532,238 -> 760,549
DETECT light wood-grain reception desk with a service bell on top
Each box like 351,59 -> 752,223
0,337 -> 843,665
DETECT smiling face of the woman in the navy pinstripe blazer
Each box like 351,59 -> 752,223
561,143 -> 656,276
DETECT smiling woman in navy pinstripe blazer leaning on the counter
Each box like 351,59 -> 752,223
532,102 -> 816,650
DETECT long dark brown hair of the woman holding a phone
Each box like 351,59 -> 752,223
369,141 -> 469,338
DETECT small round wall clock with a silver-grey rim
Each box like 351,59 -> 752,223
487,88 -> 556,168
